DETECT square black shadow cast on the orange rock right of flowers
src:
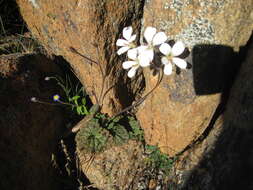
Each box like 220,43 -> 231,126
191,45 -> 240,95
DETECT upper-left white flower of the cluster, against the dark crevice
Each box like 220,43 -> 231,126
116,26 -> 136,55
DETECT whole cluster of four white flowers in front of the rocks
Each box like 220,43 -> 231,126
116,26 -> 187,78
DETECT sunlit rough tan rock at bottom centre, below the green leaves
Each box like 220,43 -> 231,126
78,140 -> 145,190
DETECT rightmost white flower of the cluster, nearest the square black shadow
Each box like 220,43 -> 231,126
159,41 -> 187,75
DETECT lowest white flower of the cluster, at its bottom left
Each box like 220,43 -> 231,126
122,48 -> 149,78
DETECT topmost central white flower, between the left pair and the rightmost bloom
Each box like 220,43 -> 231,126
140,26 -> 167,65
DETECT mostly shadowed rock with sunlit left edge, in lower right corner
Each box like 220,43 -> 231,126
169,38 -> 253,190
